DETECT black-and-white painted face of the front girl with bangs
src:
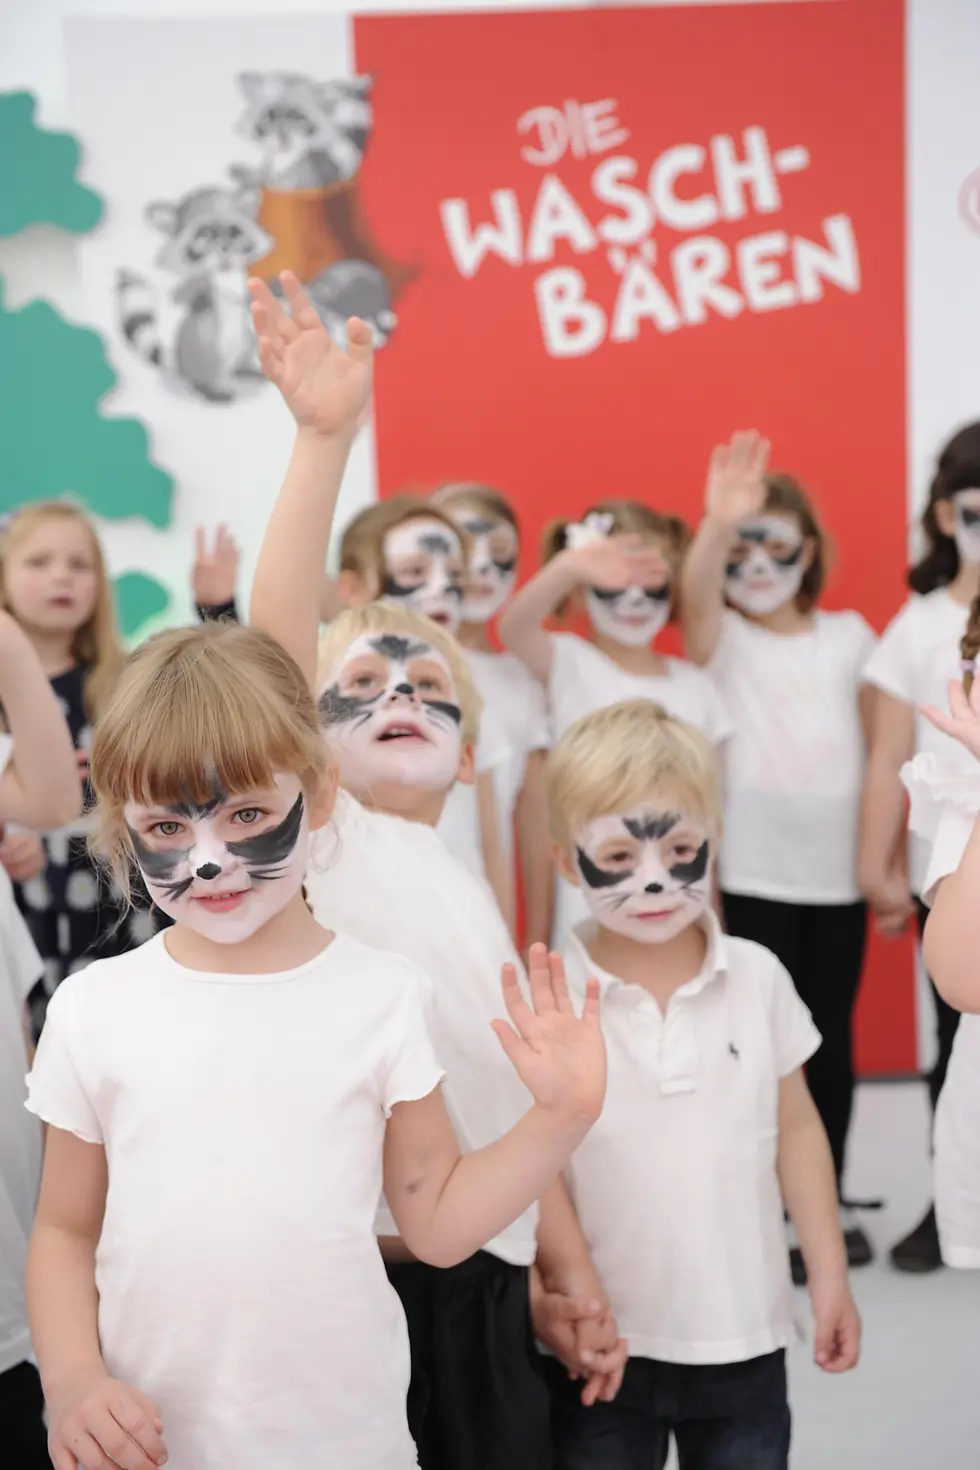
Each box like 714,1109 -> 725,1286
123,773 -> 310,944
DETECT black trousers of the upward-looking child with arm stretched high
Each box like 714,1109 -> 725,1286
388,1251 -> 551,1470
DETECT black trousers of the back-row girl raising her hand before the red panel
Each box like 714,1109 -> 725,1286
721,894 -> 867,1183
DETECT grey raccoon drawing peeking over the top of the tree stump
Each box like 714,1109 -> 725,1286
235,72 -> 372,190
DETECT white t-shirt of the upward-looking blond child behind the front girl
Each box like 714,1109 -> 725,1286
306,791 -> 538,1266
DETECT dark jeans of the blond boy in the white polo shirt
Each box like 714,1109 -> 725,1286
547,1351 -> 790,1470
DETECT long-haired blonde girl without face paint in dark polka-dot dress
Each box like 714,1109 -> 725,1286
0,501 -> 157,1035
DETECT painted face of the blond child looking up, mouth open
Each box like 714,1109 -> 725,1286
319,634 -> 463,800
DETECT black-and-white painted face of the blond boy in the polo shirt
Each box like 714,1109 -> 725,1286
574,807 -> 713,944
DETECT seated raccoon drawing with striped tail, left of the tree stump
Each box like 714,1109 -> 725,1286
116,185 -> 273,403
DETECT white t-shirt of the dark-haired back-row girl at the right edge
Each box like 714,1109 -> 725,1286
864,587 -> 974,894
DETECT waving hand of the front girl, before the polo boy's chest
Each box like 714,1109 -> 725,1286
494,944 -> 605,1123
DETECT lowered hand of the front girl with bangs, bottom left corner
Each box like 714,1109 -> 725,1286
47,1376 -> 167,1470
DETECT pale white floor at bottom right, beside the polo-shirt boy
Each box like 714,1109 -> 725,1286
658,1083 -> 980,1470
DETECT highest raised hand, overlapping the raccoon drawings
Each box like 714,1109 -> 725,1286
248,270 -> 373,435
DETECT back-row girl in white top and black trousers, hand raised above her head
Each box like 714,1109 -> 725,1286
682,434 -> 874,1282
